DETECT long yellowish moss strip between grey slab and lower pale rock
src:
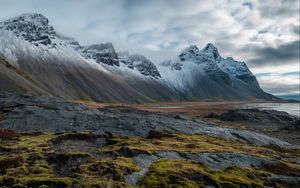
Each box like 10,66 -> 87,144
98,134 -> 281,158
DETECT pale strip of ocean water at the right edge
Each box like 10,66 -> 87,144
241,103 -> 300,117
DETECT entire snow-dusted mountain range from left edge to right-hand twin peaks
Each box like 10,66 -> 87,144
0,14 -> 274,102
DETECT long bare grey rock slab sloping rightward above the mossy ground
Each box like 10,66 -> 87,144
0,94 -> 294,148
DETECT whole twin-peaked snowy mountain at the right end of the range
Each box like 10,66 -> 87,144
158,43 -> 272,99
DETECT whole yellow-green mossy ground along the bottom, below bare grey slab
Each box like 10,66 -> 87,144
0,129 -> 300,187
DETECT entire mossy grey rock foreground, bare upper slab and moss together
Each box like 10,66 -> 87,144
0,93 -> 300,187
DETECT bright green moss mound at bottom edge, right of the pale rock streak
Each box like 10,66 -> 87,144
139,160 -> 266,187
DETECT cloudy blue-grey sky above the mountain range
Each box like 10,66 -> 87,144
0,0 -> 300,95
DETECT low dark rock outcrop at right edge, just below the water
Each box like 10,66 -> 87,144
205,109 -> 300,145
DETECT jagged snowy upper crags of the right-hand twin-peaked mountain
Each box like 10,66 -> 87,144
160,43 -> 259,88
